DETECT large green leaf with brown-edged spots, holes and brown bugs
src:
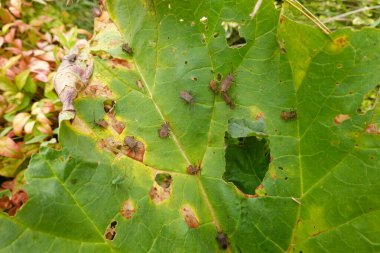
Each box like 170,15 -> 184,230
0,0 -> 380,252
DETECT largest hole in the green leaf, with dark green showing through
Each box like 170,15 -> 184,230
223,118 -> 270,194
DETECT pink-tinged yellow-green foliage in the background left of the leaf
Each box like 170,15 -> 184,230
0,1 -> 93,182
